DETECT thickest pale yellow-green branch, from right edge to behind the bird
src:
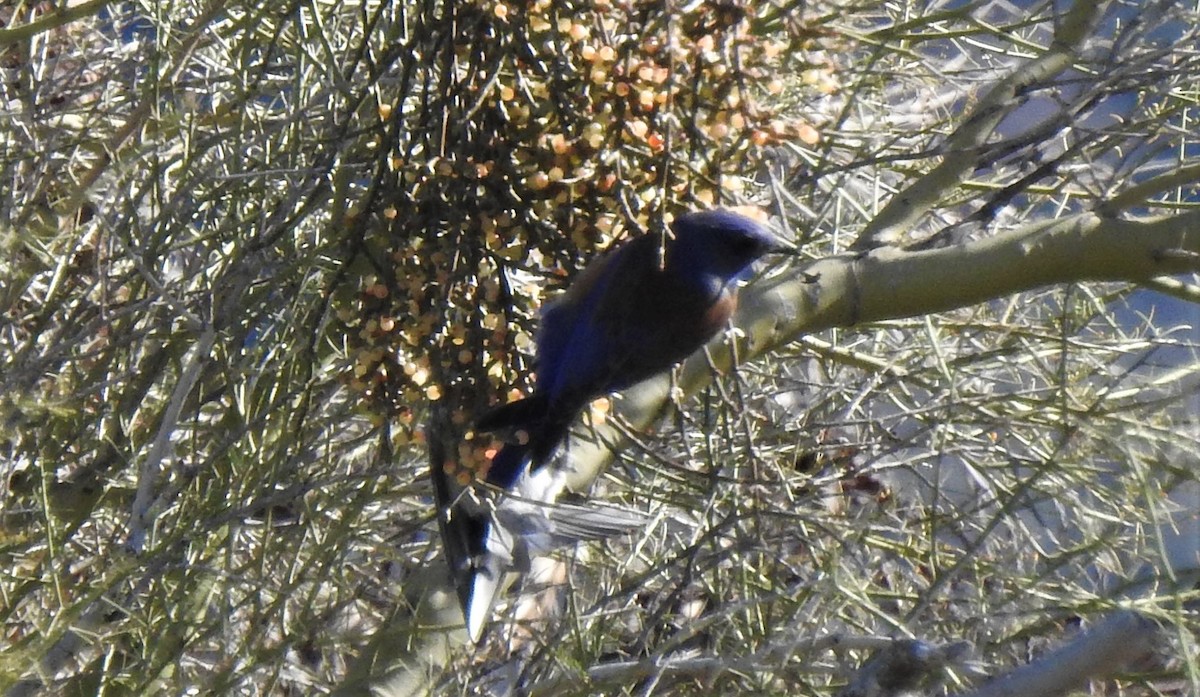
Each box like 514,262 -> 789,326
571,212 -> 1200,488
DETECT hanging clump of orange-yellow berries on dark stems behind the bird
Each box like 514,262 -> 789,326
338,0 -> 840,476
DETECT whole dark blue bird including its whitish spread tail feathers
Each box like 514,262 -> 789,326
443,209 -> 794,642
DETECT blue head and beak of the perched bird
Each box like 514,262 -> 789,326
667,209 -> 794,287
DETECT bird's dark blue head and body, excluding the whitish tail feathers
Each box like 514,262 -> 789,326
475,209 -> 791,488
